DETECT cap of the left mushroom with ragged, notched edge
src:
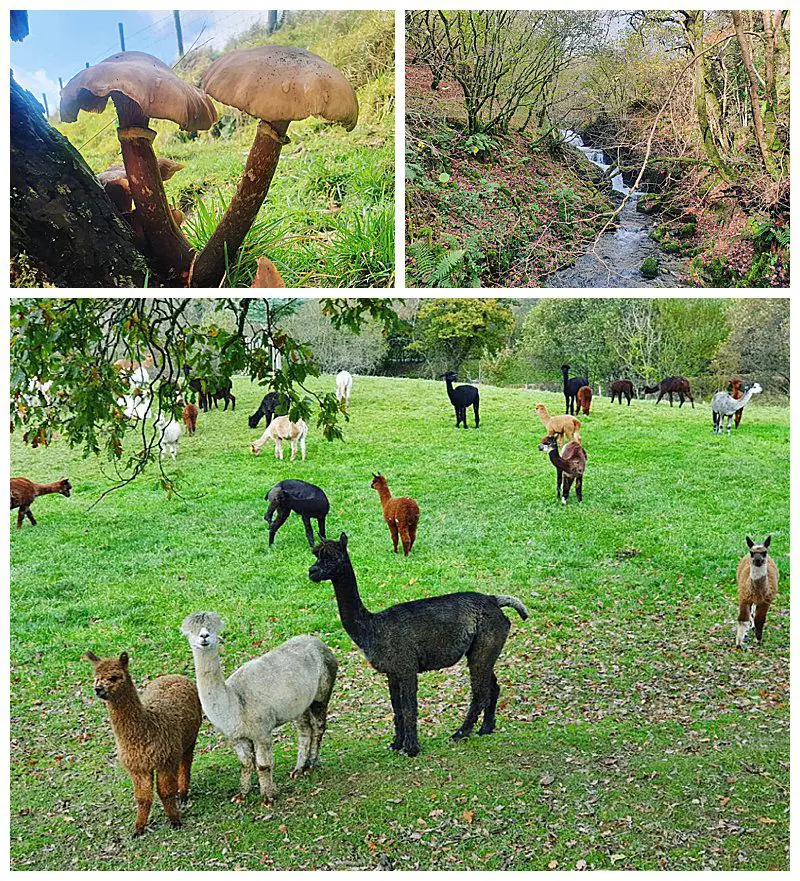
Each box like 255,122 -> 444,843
61,52 -> 217,131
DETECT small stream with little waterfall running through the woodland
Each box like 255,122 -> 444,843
544,130 -> 686,288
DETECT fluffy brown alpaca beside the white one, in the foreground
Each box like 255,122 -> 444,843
84,652 -> 203,838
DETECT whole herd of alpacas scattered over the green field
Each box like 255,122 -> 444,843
11,361 -> 778,837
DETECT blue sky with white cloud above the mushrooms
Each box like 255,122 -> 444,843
11,8 -> 276,113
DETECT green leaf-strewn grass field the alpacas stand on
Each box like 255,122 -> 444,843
11,377 -> 789,870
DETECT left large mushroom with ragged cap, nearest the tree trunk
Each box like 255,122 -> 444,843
61,52 -> 217,274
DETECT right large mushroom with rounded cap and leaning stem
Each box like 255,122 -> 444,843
192,46 -> 358,287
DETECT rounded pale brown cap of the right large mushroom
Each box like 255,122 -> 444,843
203,46 -> 358,131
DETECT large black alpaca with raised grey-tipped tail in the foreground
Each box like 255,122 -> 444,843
308,533 -> 528,756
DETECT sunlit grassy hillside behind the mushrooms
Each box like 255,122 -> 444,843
51,11 -> 394,287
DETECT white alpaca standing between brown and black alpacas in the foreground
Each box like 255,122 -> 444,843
181,612 -> 338,804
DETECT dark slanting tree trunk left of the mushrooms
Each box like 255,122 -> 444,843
11,76 -> 153,287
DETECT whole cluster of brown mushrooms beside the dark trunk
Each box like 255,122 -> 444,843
61,46 -> 358,287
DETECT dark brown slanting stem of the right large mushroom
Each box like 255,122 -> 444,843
192,120 -> 289,287
